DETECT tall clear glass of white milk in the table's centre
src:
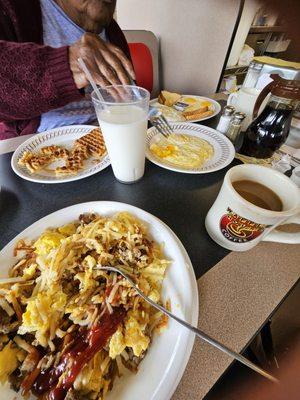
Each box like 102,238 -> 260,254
92,85 -> 150,183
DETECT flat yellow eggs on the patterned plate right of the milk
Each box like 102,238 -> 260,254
150,134 -> 214,169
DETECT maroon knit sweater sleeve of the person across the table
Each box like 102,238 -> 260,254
0,40 -> 82,121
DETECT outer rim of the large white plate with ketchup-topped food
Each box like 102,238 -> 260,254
0,200 -> 199,400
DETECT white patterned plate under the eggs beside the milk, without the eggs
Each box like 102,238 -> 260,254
146,122 -> 235,174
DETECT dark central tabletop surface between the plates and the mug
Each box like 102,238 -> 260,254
0,108 -> 236,278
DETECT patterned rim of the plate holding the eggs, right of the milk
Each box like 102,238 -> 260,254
146,122 -> 235,175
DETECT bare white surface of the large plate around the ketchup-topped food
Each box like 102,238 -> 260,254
0,201 -> 198,400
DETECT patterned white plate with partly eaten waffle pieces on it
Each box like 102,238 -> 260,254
11,125 -> 110,183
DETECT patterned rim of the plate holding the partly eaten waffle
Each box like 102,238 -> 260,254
10,125 -> 111,185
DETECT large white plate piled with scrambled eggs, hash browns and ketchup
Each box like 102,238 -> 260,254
0,201 -> 198,400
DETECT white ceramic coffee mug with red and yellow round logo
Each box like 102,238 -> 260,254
205,164 -> 300,251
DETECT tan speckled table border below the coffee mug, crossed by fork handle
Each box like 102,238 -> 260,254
172,242 -> 300,400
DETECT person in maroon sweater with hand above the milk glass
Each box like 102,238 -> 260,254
0,0 -> 135,140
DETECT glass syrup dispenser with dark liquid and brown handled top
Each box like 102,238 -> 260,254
239,75 -> 300,158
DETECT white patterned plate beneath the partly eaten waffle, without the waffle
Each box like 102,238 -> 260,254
11,125 -> 110,183
